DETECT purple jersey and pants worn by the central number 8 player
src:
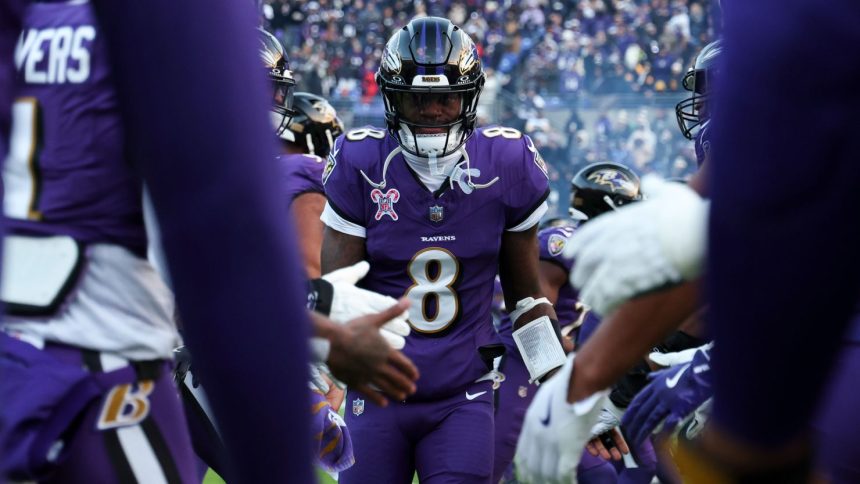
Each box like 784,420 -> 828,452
323,128 -> 548,483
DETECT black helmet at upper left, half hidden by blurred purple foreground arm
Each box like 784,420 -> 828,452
257,28 -> 296,136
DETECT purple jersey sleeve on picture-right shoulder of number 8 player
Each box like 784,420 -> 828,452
504,136 -> 549,229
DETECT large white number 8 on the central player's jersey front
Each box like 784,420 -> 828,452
406,247 -> 460,333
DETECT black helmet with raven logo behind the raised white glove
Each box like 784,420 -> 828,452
570,162 -> 642,220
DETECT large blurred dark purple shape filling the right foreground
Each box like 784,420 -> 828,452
707,0 -> 860,445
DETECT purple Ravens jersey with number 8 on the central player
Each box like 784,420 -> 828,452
322,127 -> 549,400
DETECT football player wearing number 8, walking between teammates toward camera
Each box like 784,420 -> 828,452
322,17 -> 564,483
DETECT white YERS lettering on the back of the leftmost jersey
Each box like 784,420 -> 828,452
15,25 -> 96,84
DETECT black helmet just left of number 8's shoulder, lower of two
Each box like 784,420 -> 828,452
281,92 -> 343,158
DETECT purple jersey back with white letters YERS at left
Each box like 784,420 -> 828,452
3,2 -> 146,254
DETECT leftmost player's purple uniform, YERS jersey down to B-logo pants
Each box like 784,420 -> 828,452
0,2 -> 194,482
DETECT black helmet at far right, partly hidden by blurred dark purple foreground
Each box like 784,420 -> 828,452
675,40 -> 723,139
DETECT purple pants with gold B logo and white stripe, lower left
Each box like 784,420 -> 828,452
0,341 -> 199,484
